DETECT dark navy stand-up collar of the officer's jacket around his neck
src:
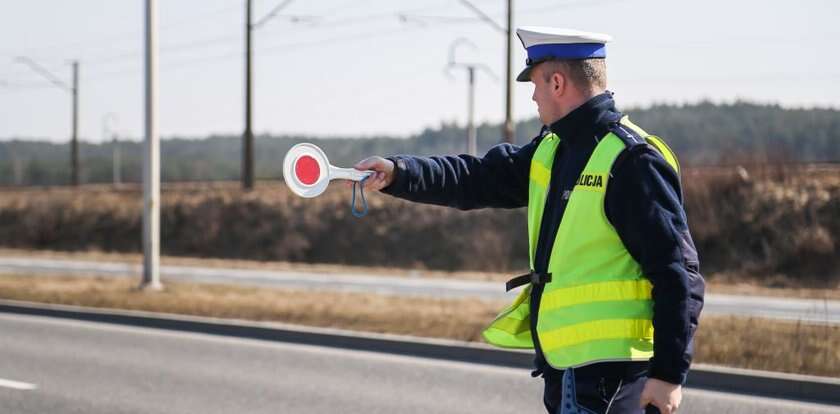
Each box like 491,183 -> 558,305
548,91 -> 621,143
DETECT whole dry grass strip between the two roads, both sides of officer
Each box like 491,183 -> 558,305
0,275 -> 840,377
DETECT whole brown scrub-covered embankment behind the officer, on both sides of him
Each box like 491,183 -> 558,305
0,163 -> 840,288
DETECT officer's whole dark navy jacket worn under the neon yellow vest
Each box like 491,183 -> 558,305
383,93 -> 705,384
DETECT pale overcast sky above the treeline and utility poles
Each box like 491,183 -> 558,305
0,0 -> 840,141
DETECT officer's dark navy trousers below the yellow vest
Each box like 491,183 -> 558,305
543,367 -> 659,414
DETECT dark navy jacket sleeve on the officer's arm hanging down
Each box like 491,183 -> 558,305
605,146 -> 705,384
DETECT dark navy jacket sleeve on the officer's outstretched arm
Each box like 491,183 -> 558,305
382,138 -> 538,210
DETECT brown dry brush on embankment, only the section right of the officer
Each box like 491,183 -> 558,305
682,164 -> 840,288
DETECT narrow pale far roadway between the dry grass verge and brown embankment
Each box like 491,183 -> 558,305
0,257 -> 840,324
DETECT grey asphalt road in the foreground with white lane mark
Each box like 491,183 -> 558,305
0,314 -> 840,414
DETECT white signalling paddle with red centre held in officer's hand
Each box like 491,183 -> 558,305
283,143 -> 373,198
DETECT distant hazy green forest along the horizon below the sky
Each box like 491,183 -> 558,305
0,102 -> 840,185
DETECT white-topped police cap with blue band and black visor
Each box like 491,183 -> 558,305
516,26 -> 612,82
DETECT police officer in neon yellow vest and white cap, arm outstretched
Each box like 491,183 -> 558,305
356,27 -> 704,414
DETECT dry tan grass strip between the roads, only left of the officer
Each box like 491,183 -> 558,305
0,275 -> 504,341
